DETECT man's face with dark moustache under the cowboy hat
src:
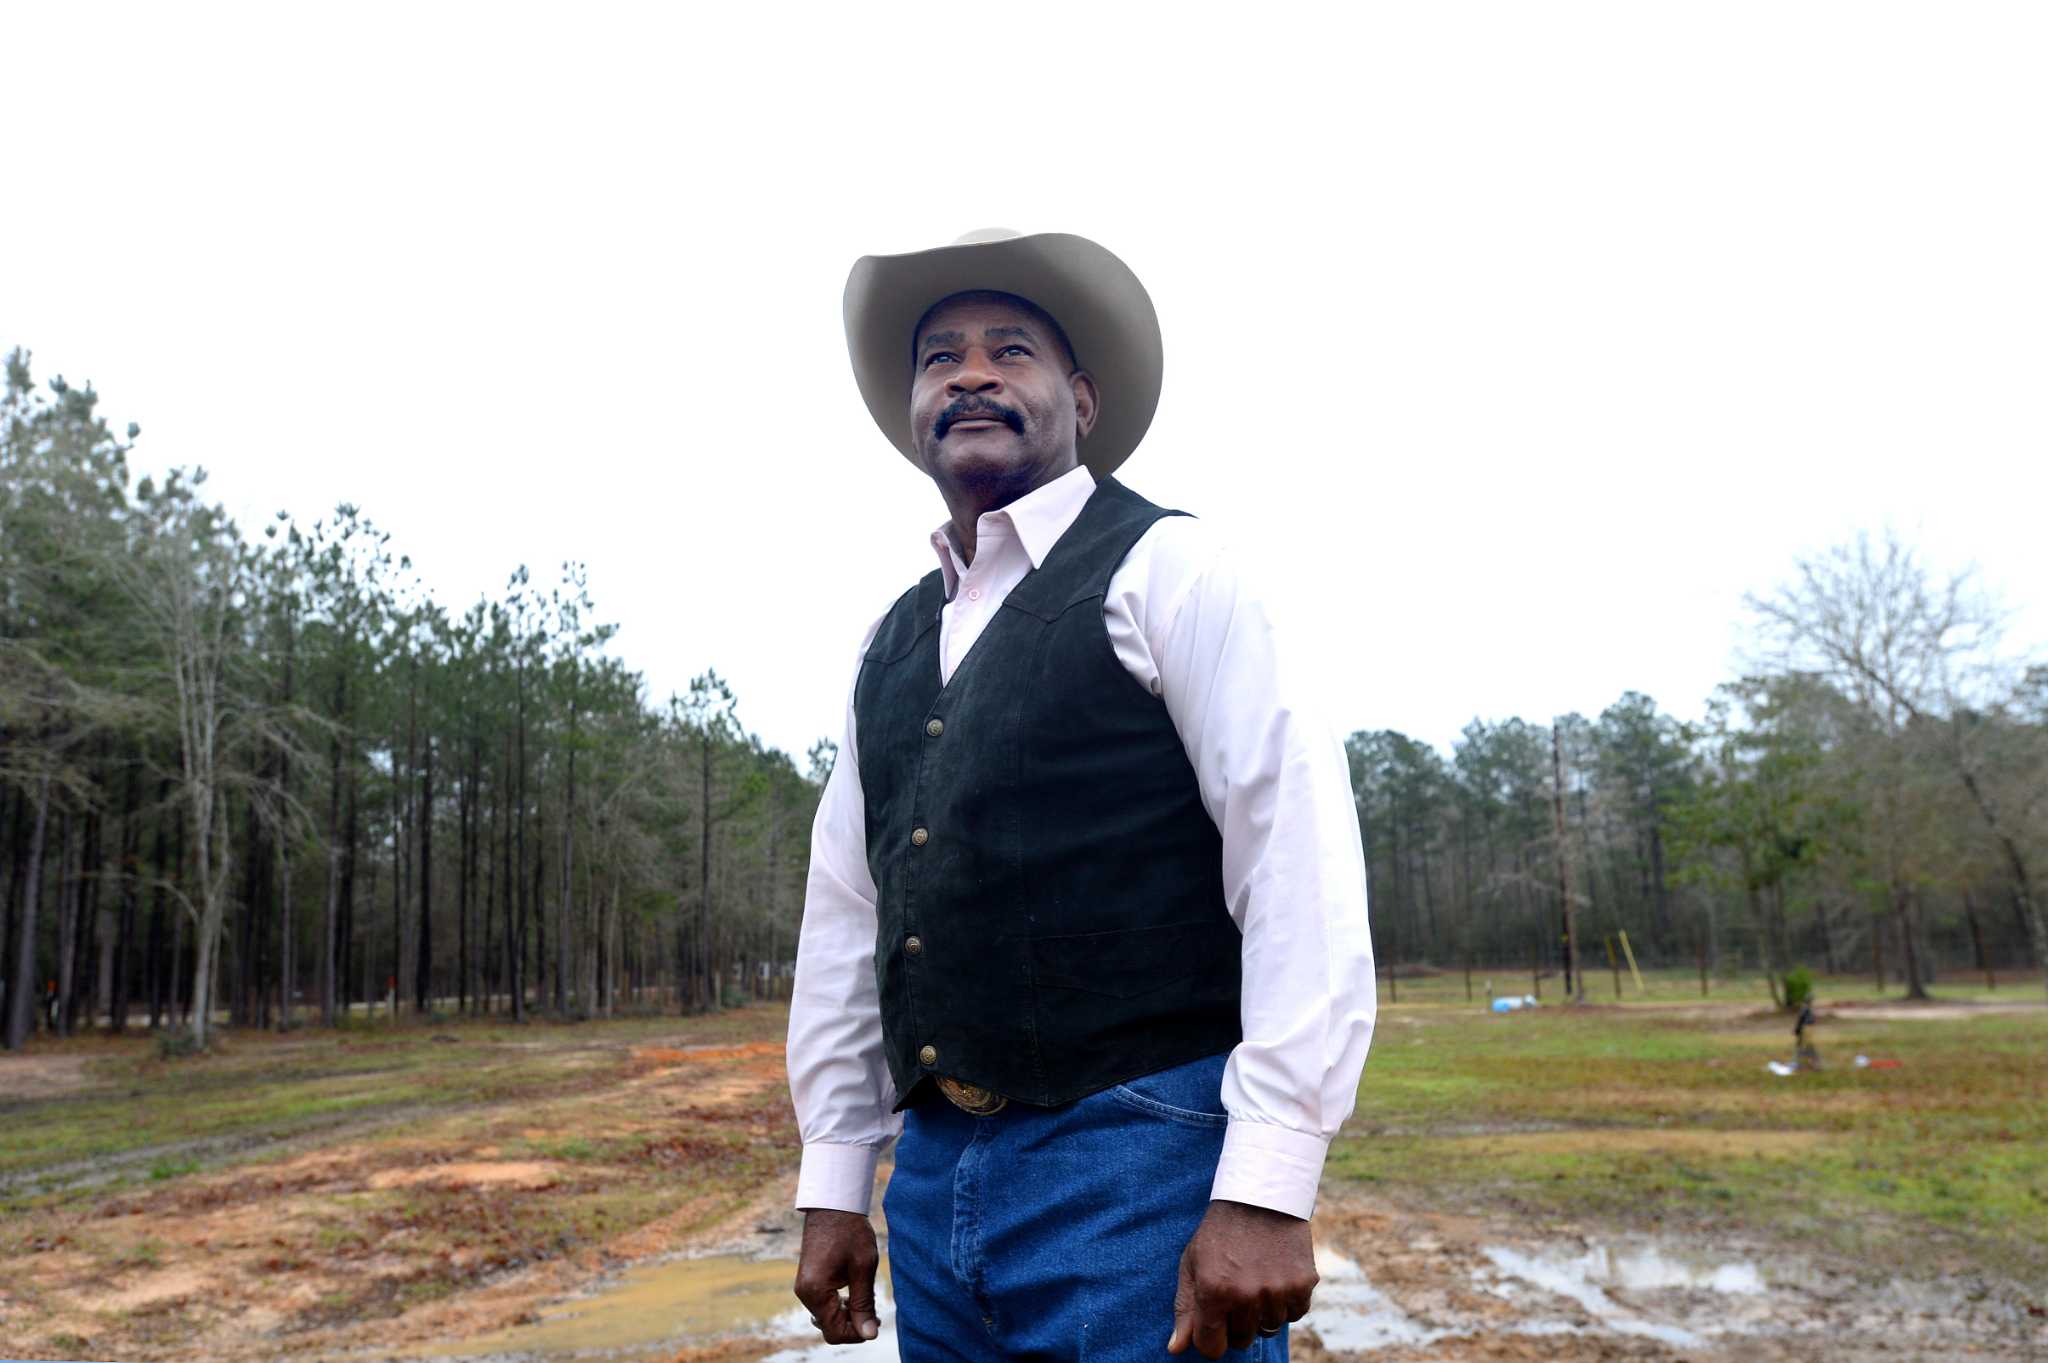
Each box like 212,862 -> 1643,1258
909,295 -> 1096,487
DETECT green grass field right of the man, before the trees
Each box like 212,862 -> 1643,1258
1329,974 -> 2048,1275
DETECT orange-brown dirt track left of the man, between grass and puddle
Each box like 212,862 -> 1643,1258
0,1040 -> 795,1363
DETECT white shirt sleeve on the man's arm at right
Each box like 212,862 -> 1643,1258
1104,518 -> 1376,1218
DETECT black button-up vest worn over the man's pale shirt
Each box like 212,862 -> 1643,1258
854,479 -> 1241,1105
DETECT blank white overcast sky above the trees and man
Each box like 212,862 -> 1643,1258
0,2 -> 2048,757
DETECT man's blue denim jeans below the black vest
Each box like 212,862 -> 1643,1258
883,1056 -> 1286,1363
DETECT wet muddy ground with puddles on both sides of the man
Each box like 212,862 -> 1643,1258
387,1195 -> 2048,1363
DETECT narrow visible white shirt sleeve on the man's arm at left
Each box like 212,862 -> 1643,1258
788,620 -> 903,1216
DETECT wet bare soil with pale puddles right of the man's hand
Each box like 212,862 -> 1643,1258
1292,1193 -> 2048,1363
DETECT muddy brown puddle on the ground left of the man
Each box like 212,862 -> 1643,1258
412,1255 -> 897,1363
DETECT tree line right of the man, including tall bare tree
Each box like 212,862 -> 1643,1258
1346,534 -> 2048,999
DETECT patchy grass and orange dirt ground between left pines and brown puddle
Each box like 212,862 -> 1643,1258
0,1005 -> 797,1357
